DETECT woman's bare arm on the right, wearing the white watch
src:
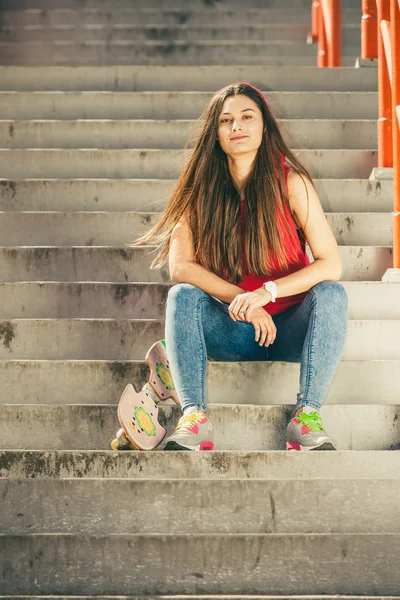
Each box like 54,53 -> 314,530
260,171 -> 342,298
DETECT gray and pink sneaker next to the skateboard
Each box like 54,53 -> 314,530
164,410 -> 214,450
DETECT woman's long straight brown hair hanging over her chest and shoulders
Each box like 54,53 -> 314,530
132,81 -> 313,284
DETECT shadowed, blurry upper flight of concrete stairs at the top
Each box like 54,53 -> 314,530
0,0 -> 361,66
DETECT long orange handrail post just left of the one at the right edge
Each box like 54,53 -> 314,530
377,0 -> 393,167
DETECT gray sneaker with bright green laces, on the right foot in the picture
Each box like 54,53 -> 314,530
286,410 -> 336,450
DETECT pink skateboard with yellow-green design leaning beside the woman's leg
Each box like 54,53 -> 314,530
111,340 -> 180,450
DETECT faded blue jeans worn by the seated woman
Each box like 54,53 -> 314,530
165,281 -> 348,411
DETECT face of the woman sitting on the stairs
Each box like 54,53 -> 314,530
217,94 -> 264,157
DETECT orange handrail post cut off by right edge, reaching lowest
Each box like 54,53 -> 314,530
390,0 -> 400,269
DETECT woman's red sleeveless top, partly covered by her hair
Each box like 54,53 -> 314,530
195,162 -> 310,315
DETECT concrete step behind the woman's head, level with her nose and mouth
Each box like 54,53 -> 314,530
0,119 -> 378,150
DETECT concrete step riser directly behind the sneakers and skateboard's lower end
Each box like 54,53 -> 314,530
0,404 -> 400,451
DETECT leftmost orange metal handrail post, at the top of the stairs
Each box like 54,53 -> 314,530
310,0 -> 342,67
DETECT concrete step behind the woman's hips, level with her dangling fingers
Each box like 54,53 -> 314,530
0,319 -> 400,360
